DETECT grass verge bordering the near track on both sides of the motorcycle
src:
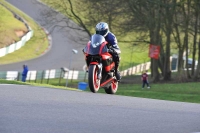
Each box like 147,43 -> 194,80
0,79 -> 200,103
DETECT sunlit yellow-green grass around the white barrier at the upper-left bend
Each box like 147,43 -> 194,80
0,0 -> 49,64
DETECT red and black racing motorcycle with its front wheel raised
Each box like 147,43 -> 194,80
83,34 -> 118,94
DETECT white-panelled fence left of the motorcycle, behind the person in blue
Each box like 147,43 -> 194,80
0,69 -> 88,85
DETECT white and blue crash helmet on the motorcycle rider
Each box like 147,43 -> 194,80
96,22 -> 109,37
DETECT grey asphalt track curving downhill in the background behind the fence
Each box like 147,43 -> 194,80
0,0 -> 87,71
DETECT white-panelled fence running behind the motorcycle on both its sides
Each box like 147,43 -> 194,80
0,62 -> 150,85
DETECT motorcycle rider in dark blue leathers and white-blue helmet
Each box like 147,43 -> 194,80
96,22 -> 121,81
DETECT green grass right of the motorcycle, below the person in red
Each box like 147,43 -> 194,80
87,83 -> 200,103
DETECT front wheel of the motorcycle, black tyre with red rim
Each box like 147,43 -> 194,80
88,65 -> 100,93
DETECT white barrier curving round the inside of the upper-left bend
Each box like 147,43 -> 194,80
0,3 -> 33,57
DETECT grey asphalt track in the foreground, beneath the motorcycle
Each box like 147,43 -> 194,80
0,85 -> 200,133
